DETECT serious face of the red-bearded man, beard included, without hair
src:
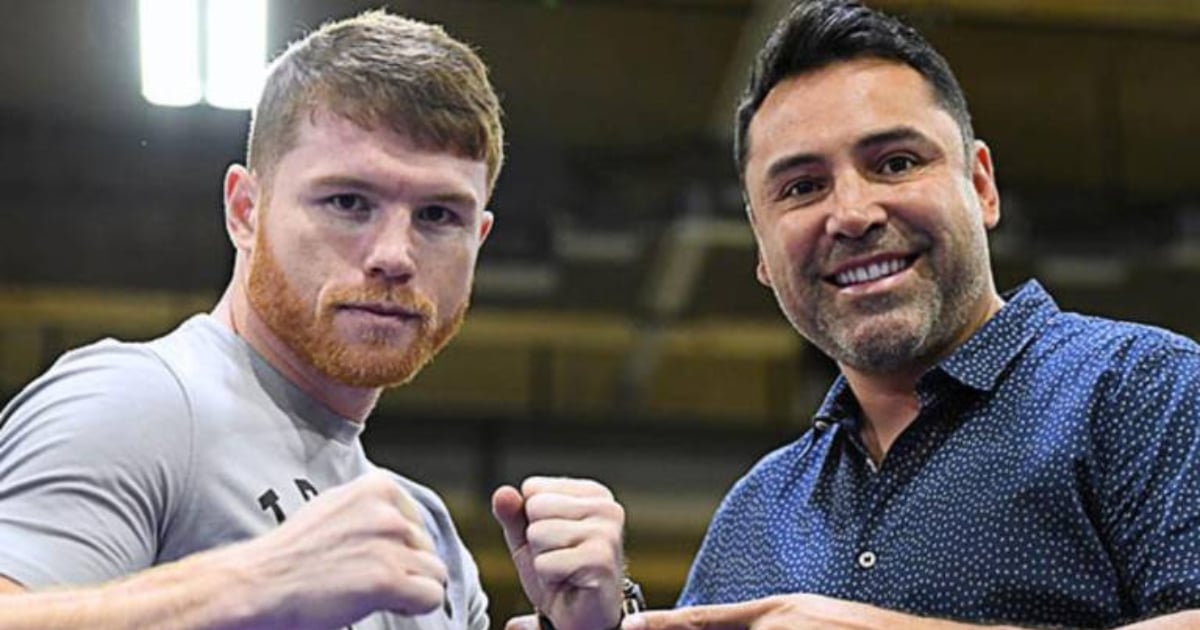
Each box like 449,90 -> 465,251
247,110 -> 492,388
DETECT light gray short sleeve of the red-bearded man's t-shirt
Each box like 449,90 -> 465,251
0,341 -> 192,588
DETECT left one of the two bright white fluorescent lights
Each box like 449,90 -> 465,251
138,0 -> 202,107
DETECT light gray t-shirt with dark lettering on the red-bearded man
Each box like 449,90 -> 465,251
0,314 -> 487,630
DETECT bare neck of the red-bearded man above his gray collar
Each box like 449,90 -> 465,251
212,272 -> 383,422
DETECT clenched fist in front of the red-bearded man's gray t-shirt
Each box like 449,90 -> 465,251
229,472 -> 448,630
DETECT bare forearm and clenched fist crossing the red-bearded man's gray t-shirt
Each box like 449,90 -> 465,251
0,472 -> 448,630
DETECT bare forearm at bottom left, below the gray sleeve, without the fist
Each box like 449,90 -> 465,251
0,540 -> 260,630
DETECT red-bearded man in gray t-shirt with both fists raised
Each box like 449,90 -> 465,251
0,12 -> 624,630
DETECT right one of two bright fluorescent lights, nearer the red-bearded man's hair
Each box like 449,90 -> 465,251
204,0 -> 266,109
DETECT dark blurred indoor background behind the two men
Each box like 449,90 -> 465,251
0,0 -> 1200,620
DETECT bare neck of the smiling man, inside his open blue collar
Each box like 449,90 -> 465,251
839,290 -> 1004,464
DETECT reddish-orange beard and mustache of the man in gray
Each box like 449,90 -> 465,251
247,226 -> 467,388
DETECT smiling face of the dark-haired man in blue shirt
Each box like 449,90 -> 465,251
744,59 -> 1000,373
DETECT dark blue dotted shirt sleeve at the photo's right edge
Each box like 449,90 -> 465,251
1094,336 -> 1200,617
